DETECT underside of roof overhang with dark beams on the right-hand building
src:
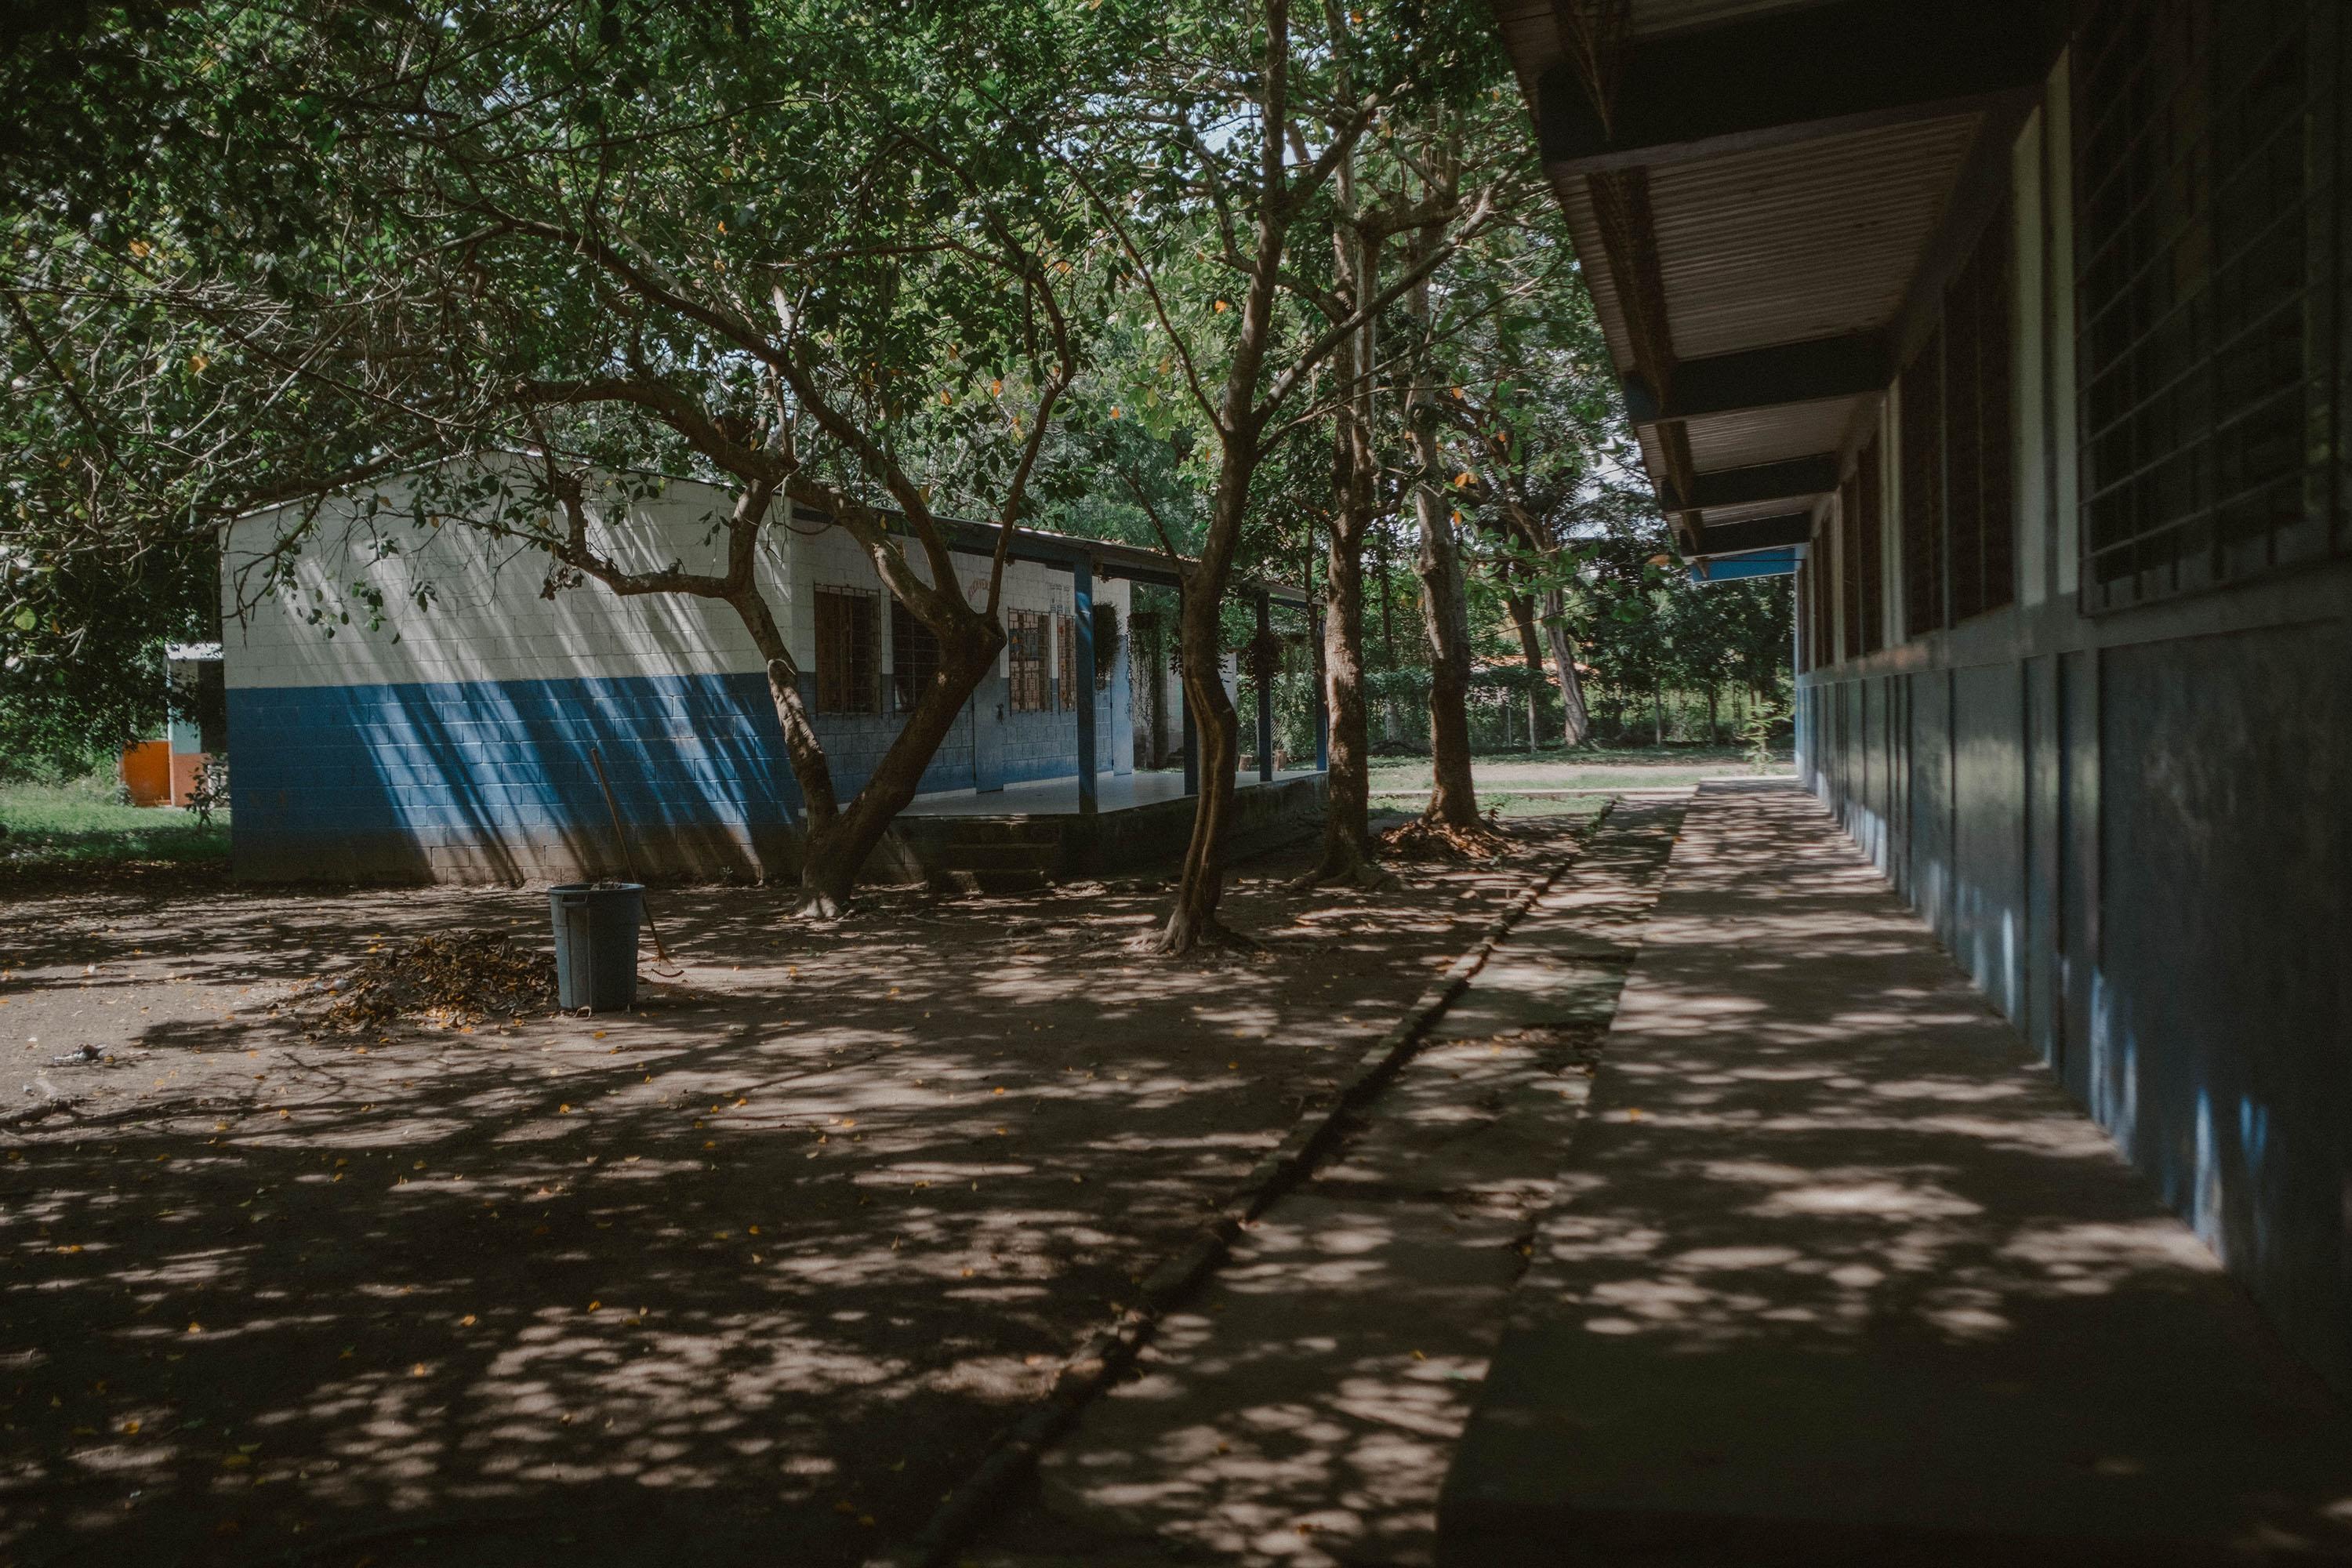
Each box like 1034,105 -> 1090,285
1491,0 -> 2063,560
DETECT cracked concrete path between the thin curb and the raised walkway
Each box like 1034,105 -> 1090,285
957,799 -> 1684,1568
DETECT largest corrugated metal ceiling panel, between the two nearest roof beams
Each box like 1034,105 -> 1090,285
1649,113 -> 1978,360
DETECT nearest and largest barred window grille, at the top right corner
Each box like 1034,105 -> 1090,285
2072,0 -> 2343,612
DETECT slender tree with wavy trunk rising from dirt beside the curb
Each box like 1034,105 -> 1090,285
1089,0 -> 1494,952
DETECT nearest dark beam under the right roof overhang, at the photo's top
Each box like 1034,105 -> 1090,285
1536,0 -> 2056,174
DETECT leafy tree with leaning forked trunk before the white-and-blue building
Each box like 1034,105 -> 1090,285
11,0 -> 1105,912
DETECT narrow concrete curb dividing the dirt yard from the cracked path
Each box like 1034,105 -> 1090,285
866,799 -> 1616,1568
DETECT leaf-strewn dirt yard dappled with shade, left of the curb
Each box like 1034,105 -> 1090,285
0,818 -> 1597,1568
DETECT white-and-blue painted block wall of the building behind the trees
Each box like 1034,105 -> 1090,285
221,459 -> 1131,881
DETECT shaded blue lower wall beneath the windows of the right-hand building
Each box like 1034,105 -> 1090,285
1799,592 -> 2352,1389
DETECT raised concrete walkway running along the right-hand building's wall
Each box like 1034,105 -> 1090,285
1439,785 -> 2352,1568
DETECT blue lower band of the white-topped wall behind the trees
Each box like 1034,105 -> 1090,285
228,675 -> 1077,881
